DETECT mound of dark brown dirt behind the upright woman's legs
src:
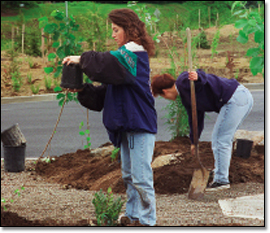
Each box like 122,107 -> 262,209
35,137 -> 264,194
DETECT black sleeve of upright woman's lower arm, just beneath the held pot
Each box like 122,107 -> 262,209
78,83 -> 107,112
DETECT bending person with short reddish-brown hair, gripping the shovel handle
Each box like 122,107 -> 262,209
152,69 -> 253,191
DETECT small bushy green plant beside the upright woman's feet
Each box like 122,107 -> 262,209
92,187 -> 125,226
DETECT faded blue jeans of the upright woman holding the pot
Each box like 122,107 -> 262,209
121,132 -> 156,226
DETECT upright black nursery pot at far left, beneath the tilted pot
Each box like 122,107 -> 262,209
3,144 -> 26,172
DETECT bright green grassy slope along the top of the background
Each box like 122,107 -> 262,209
1,1 -> 264,50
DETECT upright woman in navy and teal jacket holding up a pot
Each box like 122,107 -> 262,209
63,9 -> 157,226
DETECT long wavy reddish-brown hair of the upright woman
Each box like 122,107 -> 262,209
109,9 -> 155,56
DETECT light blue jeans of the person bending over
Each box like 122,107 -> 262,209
212,84 -> 253,184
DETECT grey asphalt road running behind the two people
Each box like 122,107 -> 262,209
1,91 -> 265,158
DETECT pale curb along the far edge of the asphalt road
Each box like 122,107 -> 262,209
1,83 -> 264,104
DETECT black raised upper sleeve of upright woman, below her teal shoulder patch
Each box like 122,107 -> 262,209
80,51 -> 135,85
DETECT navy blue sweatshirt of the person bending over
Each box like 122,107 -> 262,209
175,69 -> 239,143
